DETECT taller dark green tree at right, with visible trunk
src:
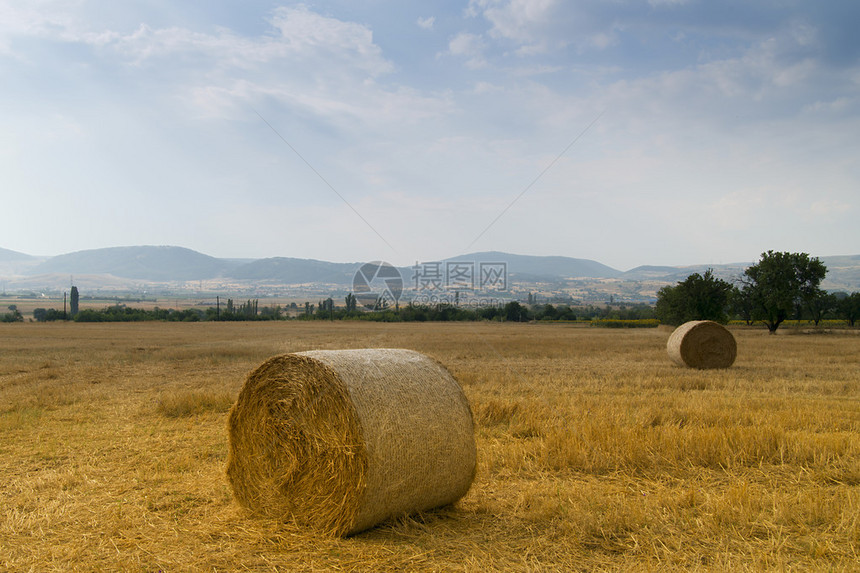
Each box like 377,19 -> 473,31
741,251 -> 827,334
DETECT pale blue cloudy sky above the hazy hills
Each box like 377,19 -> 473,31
0,0 -> 860,270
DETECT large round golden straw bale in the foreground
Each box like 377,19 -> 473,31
227,348 -> 476,535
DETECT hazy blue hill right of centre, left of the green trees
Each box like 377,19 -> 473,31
445,251 -> 622,280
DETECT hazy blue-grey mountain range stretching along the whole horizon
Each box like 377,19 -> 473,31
0,246 -> 860,291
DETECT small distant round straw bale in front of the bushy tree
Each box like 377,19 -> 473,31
666,320 -> 738,369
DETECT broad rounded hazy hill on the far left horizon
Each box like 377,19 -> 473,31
29,246 -> 233,282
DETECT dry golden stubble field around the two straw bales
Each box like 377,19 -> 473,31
0,322 -> 860,572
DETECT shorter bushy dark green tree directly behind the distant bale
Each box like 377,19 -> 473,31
655,269 -> 732,326
